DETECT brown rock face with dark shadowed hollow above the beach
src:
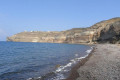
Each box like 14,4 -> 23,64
91,18 -> 120,43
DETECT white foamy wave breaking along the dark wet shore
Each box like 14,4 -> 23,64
27,46 -> 93,80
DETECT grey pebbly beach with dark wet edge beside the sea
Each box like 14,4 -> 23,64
66,44 -> 120,80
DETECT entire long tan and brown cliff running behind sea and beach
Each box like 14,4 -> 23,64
7,18 -> 120,44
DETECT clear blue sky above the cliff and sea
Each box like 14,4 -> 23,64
0,0 -> 120,41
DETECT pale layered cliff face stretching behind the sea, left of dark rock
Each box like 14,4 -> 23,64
7,29 -> 94,43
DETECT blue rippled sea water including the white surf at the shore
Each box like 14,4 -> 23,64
0,42 -> 91,80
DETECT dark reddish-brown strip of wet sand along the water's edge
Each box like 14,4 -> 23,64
64,47 -> 95,80
